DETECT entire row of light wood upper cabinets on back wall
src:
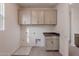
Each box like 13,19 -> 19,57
19,8 -> 57,24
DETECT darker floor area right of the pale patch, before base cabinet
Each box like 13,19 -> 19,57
30,47 -> 61,56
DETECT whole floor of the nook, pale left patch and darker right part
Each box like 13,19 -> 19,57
12,47 -> 61,56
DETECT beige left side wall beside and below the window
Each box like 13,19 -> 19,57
0,4 -> 20,55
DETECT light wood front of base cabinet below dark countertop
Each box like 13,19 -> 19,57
46,38 -> 59,50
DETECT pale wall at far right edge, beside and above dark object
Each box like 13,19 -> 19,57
71,6 -> 79,46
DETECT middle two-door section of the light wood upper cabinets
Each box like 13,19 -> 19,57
32,10 -> 44,24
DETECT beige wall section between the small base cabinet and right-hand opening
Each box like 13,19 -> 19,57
57,3 -> 70,56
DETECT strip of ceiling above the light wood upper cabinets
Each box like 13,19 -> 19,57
18,3 -> 57,8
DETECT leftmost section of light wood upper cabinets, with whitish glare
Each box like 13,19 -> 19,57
19,10 -> 31,24
